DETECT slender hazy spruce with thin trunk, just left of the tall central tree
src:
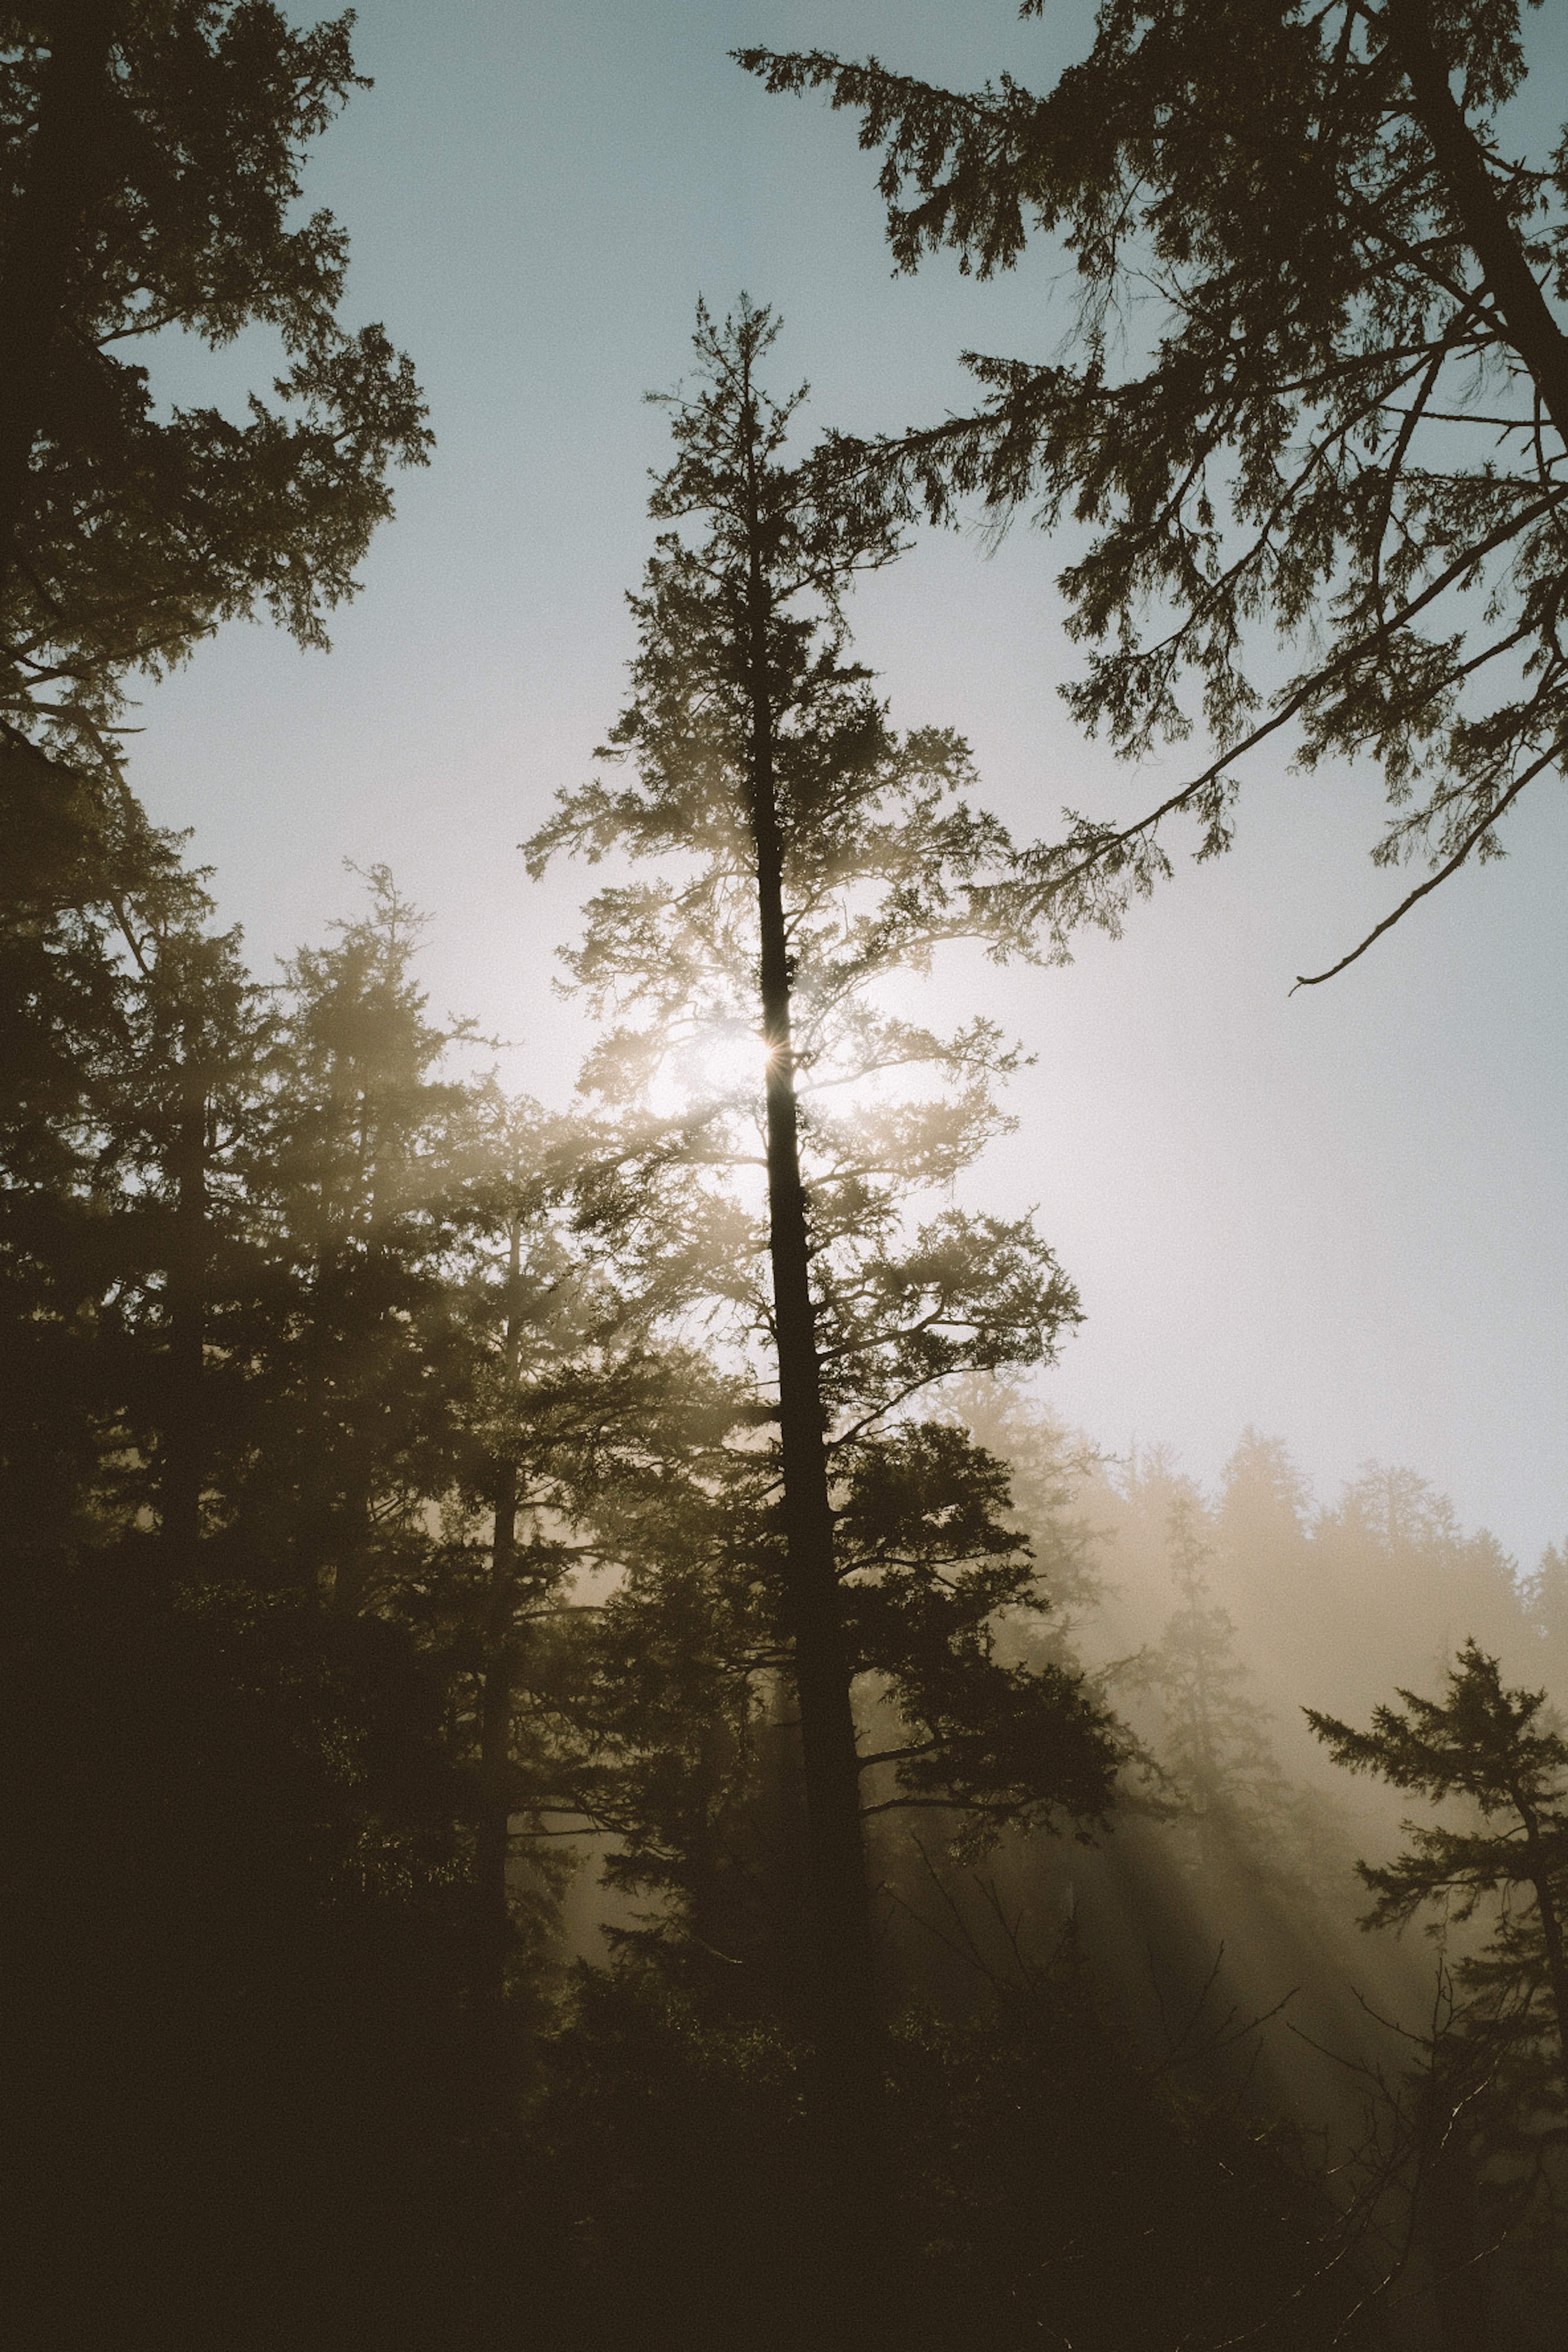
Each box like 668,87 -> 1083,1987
439,1101 -> 706,2122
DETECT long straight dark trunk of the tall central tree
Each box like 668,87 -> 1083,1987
748,428 -> 879,2152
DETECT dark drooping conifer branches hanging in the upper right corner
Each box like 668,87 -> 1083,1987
738,0 -> 1568,978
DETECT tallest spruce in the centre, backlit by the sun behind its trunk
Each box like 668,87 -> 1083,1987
527,303 -> 1109,2220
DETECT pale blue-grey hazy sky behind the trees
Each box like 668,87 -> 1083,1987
134,0 -> 1568,1566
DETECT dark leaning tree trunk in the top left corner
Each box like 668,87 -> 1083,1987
0,0 -> 118,597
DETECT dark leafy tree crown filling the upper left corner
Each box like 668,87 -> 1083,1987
0,0 -> 430,764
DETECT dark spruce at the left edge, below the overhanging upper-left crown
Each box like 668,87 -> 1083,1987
0,750 -> 273,1573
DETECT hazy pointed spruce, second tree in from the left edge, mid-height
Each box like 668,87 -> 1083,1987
245,866 -> 470,1616
